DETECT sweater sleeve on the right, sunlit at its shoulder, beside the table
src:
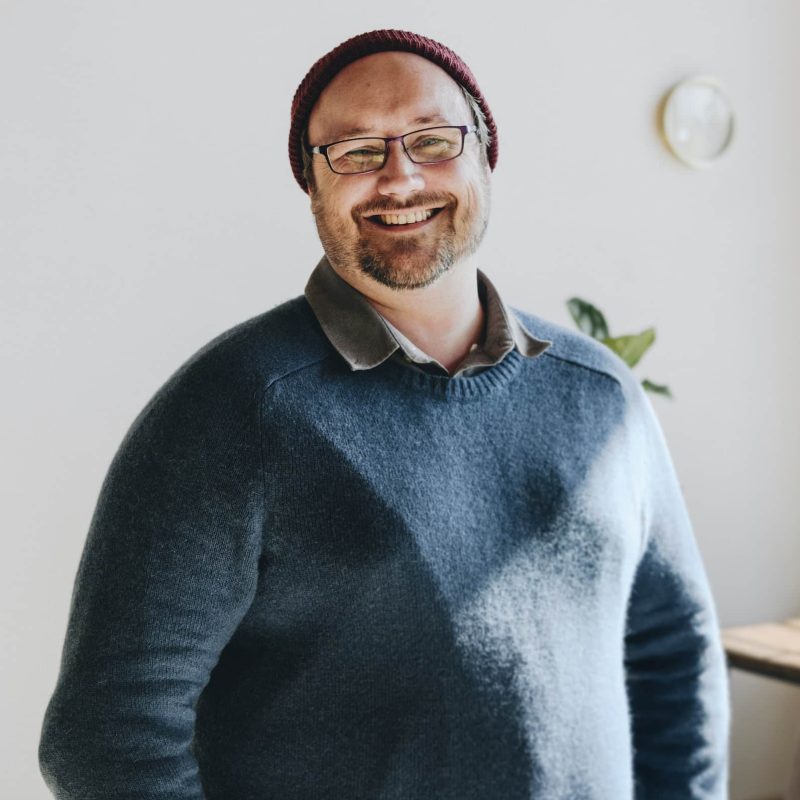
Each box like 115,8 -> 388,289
625,385 -> 729,800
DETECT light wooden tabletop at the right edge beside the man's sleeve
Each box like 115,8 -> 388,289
722,617 -> 800,684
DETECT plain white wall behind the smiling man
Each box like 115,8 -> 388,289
0,0 -> 800,800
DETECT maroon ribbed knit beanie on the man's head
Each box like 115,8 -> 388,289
289,29 -> 497,193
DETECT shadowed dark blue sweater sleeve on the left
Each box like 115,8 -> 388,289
39,362 -> 263,800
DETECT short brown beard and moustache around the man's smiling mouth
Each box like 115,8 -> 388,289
312,171 -> 490,289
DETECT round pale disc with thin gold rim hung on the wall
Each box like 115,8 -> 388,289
661,75 -> 733,168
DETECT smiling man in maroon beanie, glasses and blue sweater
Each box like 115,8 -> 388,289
40,30 -> 728,800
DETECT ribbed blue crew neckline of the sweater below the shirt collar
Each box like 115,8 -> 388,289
373,349 -> 526,402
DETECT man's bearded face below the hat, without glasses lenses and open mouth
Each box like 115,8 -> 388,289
308,52 -> 490,289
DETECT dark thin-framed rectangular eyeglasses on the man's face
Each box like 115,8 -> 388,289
306,125 -> 478,175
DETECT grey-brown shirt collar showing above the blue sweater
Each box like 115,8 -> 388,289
305,256 -> 551,377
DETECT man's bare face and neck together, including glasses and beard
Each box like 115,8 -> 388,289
300,51 -> 494,370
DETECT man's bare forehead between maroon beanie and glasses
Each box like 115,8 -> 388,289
308,52 -> 472,142
